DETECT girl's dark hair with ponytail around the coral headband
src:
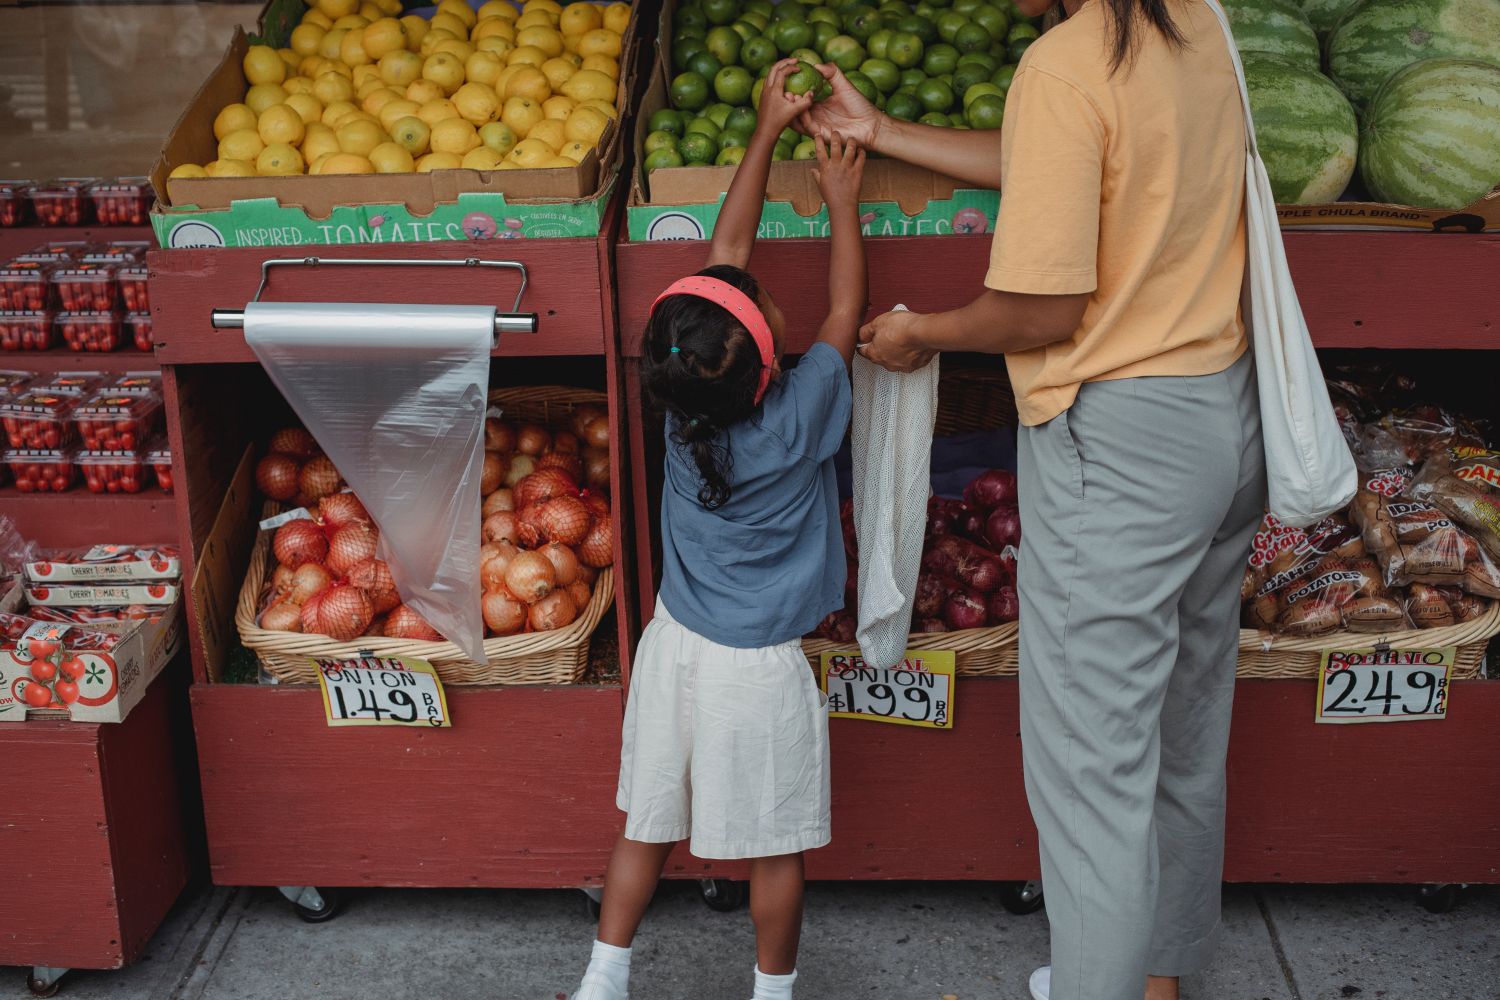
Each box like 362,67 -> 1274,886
644,264 -> 761,510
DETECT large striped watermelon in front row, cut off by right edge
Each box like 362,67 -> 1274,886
1359,58 -> 1500,208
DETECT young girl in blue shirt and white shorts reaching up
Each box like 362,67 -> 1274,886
575,60 -> 866,1000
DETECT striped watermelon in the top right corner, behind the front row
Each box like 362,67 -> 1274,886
1328,0 -> 1500,108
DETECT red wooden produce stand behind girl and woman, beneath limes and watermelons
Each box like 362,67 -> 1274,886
617,232 -> 1500,883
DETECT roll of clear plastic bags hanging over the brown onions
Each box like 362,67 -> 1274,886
245,301 -> 495,661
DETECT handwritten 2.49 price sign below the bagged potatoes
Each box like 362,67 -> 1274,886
1317,646 -> 1458,723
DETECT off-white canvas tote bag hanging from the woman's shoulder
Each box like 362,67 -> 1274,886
1206,0 -> 1358,528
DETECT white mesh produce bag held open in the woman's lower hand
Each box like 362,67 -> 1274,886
854,306 -> 938,667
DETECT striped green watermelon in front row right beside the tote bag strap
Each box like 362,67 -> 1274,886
1245,55 -> 1359,205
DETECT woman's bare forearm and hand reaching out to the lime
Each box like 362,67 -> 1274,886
798,66 -> 1001,190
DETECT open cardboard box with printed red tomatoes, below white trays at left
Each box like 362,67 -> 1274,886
0,603 -> 183,723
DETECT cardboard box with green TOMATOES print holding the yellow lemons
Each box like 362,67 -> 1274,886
152,0 -> 635,249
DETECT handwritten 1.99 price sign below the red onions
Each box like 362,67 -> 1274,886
818,649 -> 956,729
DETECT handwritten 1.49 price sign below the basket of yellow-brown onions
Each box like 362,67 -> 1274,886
314,657 -> 452,729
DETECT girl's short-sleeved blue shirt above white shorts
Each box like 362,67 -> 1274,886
660,343 -> 852,649
